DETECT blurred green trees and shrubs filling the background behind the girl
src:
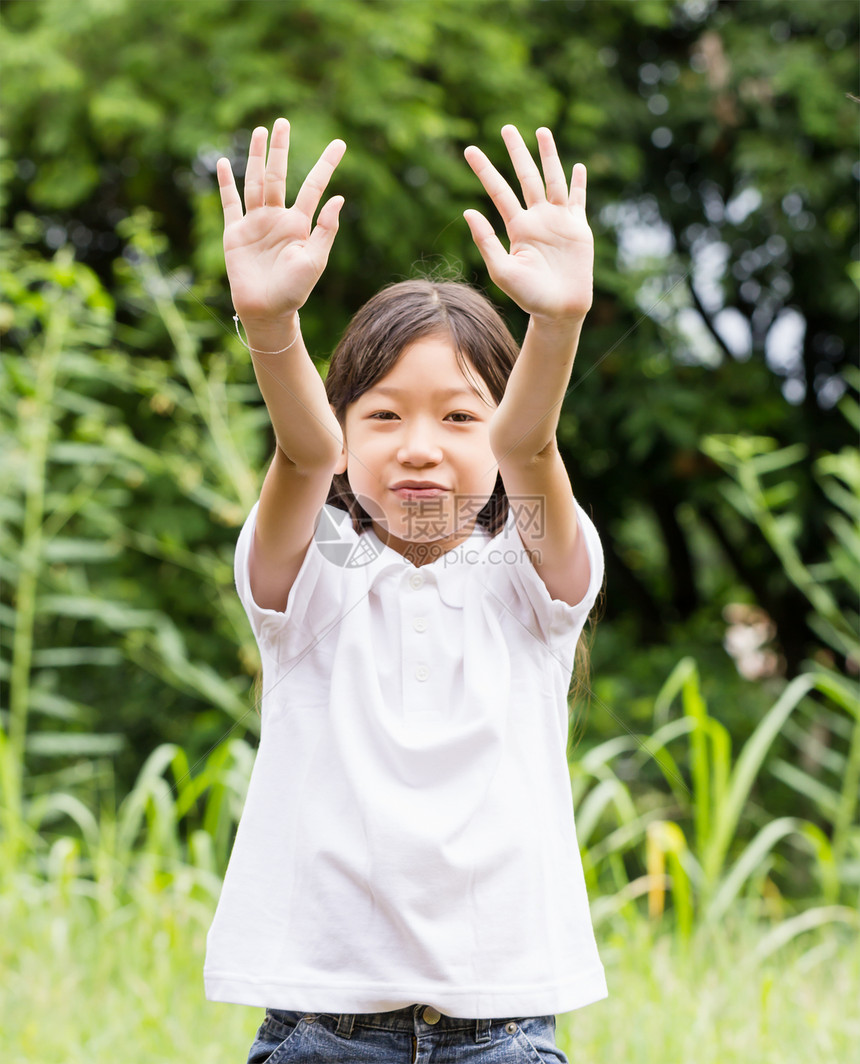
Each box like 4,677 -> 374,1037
0,0 -> 860,815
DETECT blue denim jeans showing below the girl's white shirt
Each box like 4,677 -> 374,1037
248,1004 -> 567,1064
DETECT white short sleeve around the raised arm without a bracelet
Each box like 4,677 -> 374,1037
489,500 -> 603,648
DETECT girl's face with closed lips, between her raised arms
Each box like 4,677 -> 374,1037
336,336 -> 498,564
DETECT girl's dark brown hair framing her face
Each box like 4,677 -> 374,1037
326,280 -> 519,535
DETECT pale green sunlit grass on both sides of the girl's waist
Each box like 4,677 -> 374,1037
0,881 -> 860,1064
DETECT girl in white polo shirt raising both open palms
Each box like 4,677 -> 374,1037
205,119 -> 606,1064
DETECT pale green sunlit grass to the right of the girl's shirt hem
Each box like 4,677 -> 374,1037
559,920 -> 860,1064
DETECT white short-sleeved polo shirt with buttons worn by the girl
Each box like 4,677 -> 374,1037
204,497 -> 607,1018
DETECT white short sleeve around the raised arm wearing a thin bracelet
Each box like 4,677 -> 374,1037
233,503 -> 342,664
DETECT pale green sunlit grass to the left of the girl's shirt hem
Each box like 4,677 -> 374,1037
0,896 -> 262,1064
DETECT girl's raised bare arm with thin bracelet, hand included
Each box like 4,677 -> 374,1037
218,118 -> 346,610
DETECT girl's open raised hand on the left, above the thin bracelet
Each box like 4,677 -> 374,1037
217,118 -> 346,330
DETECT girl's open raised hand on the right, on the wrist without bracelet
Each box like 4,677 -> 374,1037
463,126 -> 594,321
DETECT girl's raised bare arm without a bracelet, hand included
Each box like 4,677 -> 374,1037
465,126 -> 594,604
